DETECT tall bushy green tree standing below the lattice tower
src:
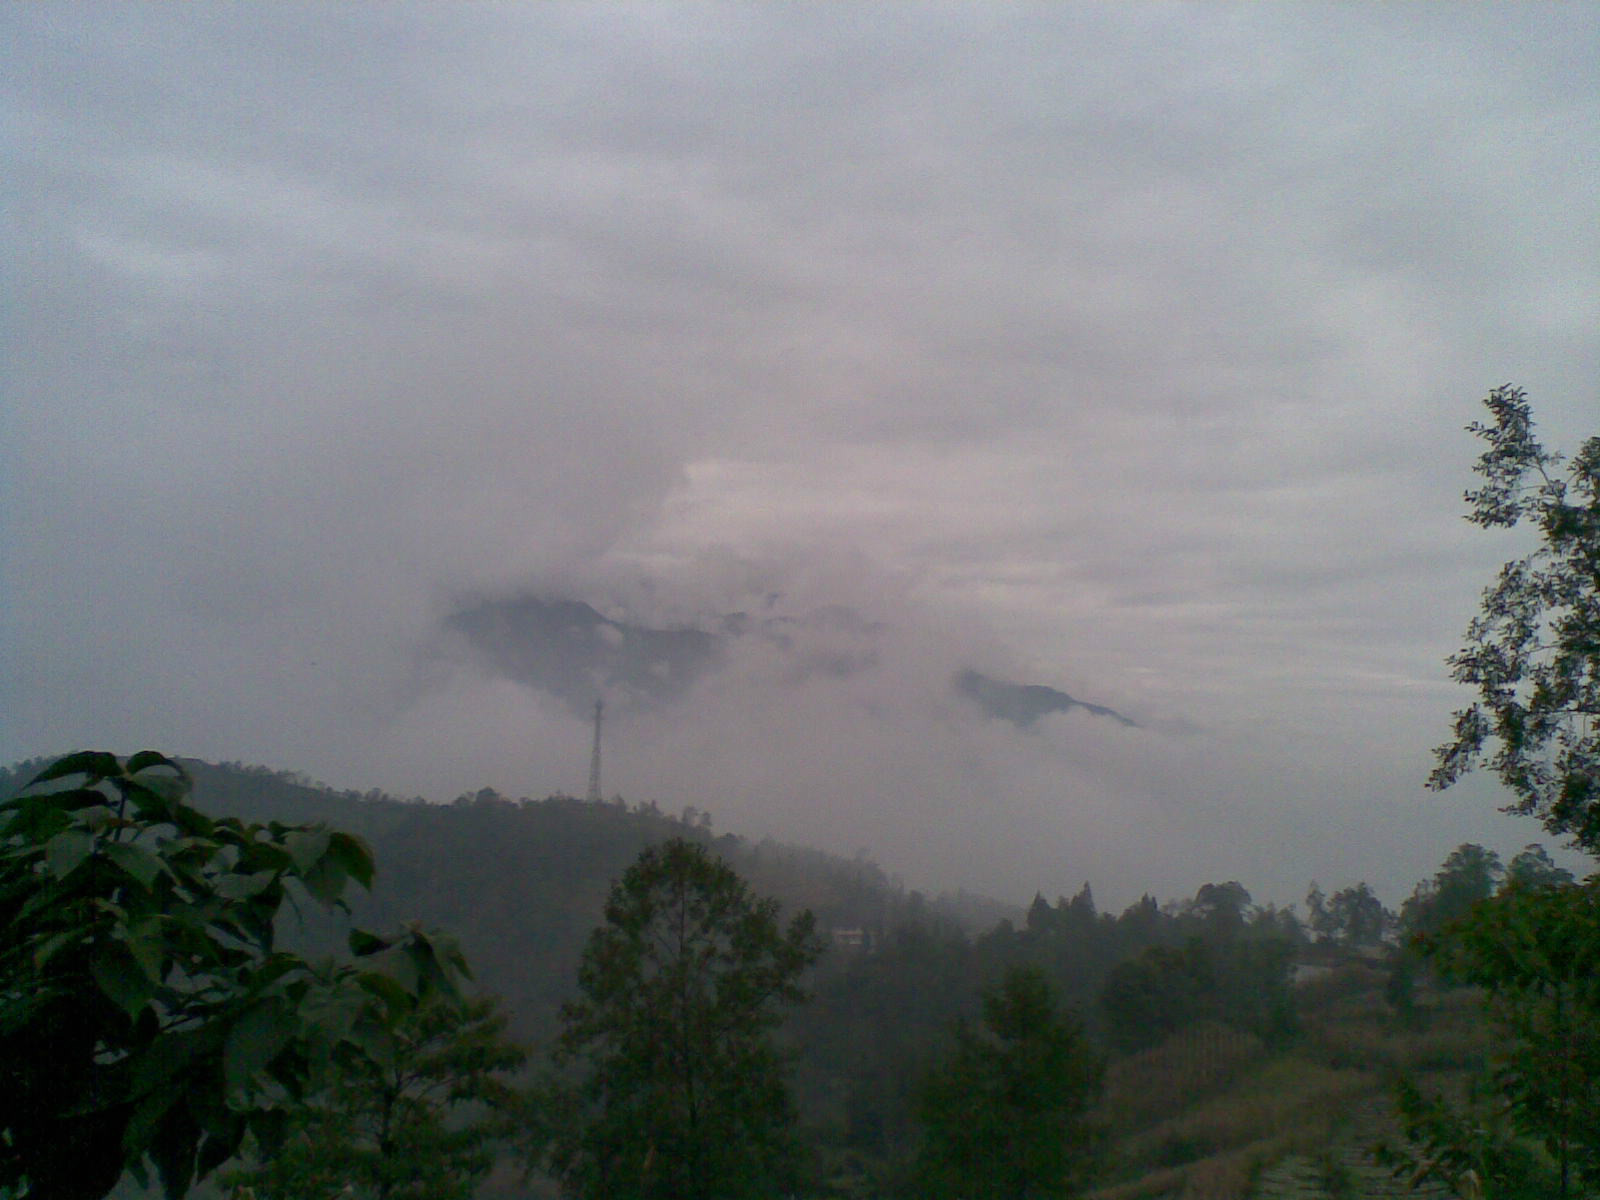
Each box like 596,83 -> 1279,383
554,838 -> 822,1200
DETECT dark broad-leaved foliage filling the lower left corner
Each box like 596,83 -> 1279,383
0,750 -> 466,1200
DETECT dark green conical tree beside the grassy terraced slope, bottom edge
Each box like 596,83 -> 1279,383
915,966 -> 1104,1200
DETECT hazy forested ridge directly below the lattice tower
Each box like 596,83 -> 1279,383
0,760 -> 966,1038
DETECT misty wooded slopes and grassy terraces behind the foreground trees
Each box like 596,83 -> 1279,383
0,760 -> 1570,1198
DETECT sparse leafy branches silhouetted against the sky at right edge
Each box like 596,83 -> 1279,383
1429,386 -> 1600,853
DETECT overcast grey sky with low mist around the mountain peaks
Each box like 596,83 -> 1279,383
0,3 -> 1600,906
